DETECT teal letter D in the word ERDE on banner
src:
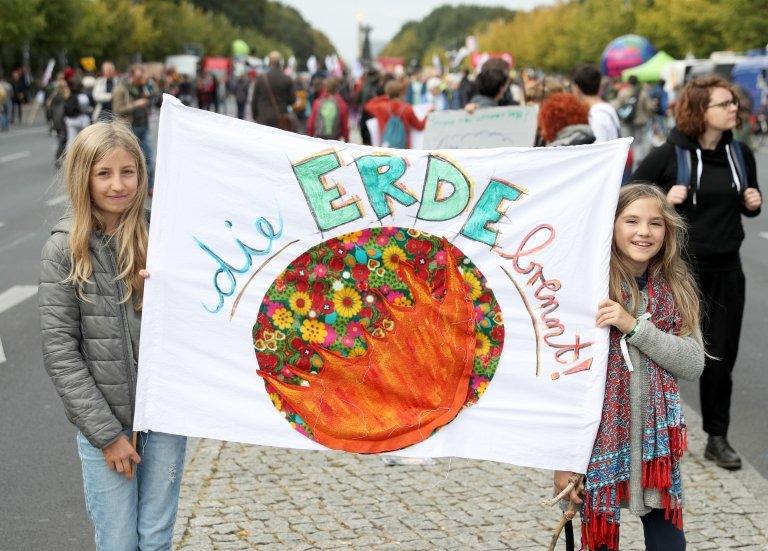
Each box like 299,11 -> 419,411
416,155 -> 470,221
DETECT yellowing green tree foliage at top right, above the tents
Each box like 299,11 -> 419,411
478,0 -> 768,71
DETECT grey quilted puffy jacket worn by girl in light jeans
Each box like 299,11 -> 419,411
38,217 -> 137,449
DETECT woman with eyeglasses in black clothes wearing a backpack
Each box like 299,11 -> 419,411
631,77 -> 762,470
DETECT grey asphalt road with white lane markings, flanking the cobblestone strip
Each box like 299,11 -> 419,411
0,123 -> 768,551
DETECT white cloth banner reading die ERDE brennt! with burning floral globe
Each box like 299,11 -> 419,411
134,96 -> 628,472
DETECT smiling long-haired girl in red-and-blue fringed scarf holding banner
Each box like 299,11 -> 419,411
555,184 -> 704,551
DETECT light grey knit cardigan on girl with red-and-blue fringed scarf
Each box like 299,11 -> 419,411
623,288 -> 704,515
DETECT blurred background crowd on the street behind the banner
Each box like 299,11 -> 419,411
7,48 -> 751,179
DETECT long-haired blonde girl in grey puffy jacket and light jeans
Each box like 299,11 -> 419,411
38,121 -> 186,551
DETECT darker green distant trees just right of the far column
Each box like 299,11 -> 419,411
380,5 -> 515,65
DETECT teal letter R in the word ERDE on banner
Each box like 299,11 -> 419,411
355,155 -> 416,220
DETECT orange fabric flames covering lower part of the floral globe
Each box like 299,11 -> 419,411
255,226 -> 500,453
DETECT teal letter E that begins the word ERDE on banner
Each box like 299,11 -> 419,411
293,152 -> 363,231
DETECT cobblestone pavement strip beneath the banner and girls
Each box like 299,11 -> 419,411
175,404 -> 768,551
